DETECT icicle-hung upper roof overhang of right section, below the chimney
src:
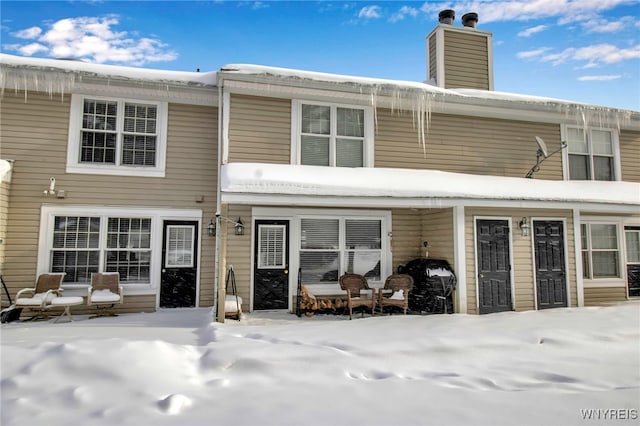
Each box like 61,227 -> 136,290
218,64 -> 640,131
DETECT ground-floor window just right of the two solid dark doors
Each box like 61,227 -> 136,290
580,223 -> 620,279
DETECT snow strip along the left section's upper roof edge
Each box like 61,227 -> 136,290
0,53 -> 217,89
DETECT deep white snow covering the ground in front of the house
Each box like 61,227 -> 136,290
0,303 -> 640,426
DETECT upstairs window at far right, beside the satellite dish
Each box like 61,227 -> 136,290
565,127 -> 618,180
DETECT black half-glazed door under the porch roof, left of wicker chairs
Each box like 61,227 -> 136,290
253,220 -> 289,310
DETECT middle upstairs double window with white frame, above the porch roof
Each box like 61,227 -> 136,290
292,101 -> 373,167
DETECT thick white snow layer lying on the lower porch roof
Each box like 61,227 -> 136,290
221,163 -> 640,206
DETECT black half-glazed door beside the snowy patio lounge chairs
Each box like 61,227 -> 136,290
160,220 -> 198,308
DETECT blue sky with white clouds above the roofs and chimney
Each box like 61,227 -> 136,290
0,0 -> 640,110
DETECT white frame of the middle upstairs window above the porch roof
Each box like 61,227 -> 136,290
291,99 -> 374,167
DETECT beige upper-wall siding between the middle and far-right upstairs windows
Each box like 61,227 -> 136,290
375,109 -> 562,180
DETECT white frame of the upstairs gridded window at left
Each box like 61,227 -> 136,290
66,94 -> 168,177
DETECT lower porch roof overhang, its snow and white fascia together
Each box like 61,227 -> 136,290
221,163 -> 640,214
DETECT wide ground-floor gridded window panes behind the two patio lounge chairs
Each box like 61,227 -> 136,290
50,216 -> 152,284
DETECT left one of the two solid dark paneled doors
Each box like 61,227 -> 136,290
476,219 -> 512,314
